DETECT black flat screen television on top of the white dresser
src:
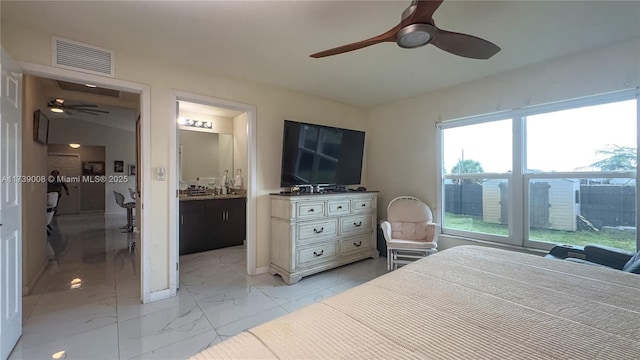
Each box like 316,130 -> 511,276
280,120 -> 364,187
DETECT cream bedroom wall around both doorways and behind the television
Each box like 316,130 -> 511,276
2,21 -> 366,292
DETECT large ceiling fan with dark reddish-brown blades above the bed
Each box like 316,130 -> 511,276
311,0 -> 500,59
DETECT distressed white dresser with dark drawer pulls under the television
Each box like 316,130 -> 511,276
269,192 -> 379,284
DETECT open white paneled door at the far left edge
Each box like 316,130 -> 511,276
0,48 -> 22,359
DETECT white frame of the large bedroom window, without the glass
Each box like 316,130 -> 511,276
436,88 -> 640,250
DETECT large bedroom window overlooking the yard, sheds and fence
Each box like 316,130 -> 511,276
438,92 -> 639,251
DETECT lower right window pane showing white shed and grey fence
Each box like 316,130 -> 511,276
529,178 -> 636,251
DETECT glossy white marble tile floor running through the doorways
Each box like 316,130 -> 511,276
9,214 -> 386,360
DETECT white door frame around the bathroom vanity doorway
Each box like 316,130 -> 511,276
169,90 -> 258,289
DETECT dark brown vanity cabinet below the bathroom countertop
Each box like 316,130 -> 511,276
180,198 -> 247,255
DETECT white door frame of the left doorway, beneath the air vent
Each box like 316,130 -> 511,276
20,62 -> 156,303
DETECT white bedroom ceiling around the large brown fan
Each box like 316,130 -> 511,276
2,0 -> 640,108
